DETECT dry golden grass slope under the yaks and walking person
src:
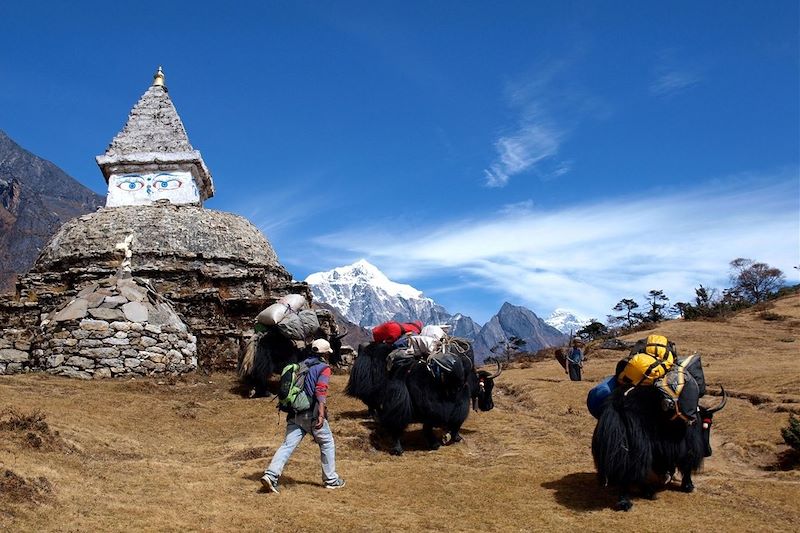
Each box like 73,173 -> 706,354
0,295 -> 800,531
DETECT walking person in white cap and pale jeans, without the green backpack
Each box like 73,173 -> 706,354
261,339 -> 345,493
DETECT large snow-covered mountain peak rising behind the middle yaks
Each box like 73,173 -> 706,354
305,259 -> 451,327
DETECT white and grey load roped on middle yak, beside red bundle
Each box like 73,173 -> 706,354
373,321 -> 472,381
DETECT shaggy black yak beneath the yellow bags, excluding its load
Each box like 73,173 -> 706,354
592,387 -> 727,511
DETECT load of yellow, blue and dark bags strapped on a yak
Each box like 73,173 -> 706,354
586,335 -> 706,424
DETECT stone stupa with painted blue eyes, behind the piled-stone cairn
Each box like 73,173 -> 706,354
0,67 -> 316,373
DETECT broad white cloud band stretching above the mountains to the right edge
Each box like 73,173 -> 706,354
314,175 -> 800,319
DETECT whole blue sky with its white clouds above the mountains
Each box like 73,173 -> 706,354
0,0 -> 800,322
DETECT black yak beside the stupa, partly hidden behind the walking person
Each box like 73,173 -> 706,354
237,326 -> 340,398
